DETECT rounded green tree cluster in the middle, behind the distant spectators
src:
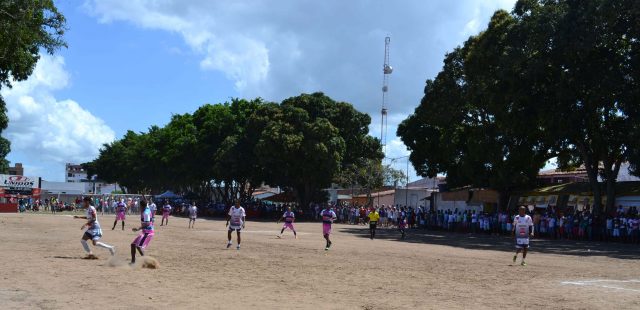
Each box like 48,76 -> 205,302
87,93 -> 382,204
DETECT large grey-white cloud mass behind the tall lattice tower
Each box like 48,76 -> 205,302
84,0 -> 515,179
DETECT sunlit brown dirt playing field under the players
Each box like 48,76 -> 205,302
0,214 -> 640,310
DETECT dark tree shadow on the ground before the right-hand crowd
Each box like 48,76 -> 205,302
338,226 -> 640,259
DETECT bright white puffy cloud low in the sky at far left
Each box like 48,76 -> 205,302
2,56 -> 115,180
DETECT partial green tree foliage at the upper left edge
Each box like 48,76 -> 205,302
0,0 -> 66,172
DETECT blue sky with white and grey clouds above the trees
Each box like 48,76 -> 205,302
2,0 -> 514,180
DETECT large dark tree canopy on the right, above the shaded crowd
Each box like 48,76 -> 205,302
398,0 -> 640,211
